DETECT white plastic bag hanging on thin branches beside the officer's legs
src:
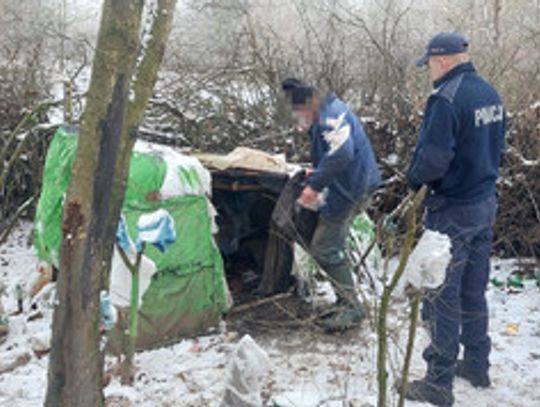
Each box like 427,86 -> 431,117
396,229 -> 452,295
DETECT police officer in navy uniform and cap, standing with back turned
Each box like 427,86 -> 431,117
406,33 -> 506,406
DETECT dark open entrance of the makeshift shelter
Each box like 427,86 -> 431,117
212,169 -> 293,303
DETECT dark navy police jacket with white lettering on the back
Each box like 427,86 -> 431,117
407,63 -> 506,209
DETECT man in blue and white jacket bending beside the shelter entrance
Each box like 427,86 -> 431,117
282,78 -> 381,330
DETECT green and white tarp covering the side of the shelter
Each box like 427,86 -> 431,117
34,128 -> 227,348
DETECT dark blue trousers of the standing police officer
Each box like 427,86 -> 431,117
422,197 -> 497,388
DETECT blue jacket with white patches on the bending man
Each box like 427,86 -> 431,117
307,95 -> 381,217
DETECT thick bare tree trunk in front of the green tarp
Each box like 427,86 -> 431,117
45,0 -> 176,407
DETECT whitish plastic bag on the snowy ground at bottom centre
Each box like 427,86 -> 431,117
221,335 -> 270,407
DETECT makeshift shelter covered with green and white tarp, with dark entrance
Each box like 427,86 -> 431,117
34,128 -> 380,348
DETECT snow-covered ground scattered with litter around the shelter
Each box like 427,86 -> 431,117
0,224 -> 540,407
